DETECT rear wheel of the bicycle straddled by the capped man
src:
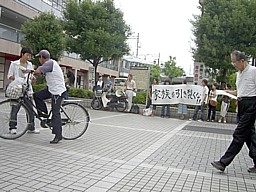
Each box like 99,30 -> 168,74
61,102 -> 90,140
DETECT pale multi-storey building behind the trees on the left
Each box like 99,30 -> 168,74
0,0 -> 119,89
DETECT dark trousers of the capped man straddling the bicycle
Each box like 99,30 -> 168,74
34,87 -> 63,137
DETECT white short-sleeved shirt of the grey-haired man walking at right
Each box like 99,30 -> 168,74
236,65 -> 256,97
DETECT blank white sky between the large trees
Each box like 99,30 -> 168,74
114,0 -> 200,74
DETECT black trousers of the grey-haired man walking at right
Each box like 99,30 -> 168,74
220,97 -> 256,166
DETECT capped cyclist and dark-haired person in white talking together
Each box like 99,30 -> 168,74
7,47 -> 67,144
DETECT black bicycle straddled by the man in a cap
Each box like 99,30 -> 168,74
0,71 -> 90,140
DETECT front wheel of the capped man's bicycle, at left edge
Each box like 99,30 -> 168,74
0,99 -> 30,139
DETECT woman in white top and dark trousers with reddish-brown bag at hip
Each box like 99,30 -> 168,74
207,83 -> 218,122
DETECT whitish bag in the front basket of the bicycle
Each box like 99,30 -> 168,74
5,78 -> 24,99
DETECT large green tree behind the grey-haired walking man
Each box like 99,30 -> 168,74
191,0 -> 256,85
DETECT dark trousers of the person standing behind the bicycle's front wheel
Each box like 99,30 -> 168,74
9,97 -> 35,130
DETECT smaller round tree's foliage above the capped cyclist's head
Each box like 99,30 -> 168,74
22,13 -> 65,64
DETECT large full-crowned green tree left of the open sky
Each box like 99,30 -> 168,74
64,0 -> 130,83
